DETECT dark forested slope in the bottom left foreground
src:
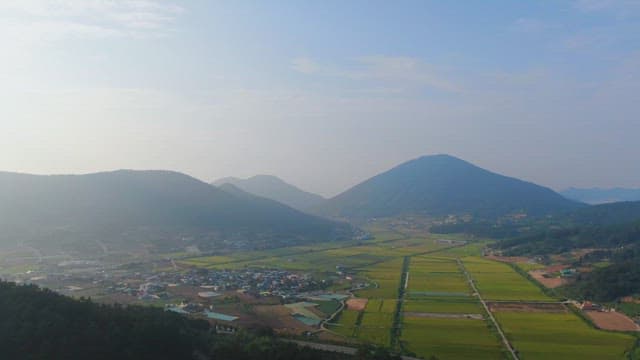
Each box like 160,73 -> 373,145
0,282 -> 394,360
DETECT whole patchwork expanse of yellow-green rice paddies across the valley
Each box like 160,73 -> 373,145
181,225 -> 636,360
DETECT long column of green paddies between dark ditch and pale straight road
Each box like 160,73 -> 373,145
400,253 -> 503,359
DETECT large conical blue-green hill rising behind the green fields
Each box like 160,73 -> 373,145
315,155 -> 583,218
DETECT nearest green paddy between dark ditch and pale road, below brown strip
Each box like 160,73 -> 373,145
400,316 -> 504,360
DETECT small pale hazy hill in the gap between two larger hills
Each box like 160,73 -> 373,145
213,175 -> 325,211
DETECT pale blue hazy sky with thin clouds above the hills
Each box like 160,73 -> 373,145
0,0 -> 640,196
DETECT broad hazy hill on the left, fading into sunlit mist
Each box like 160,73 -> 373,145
0,170 -> 350,253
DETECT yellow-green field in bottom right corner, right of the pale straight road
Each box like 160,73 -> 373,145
495,312 -> 635,360
